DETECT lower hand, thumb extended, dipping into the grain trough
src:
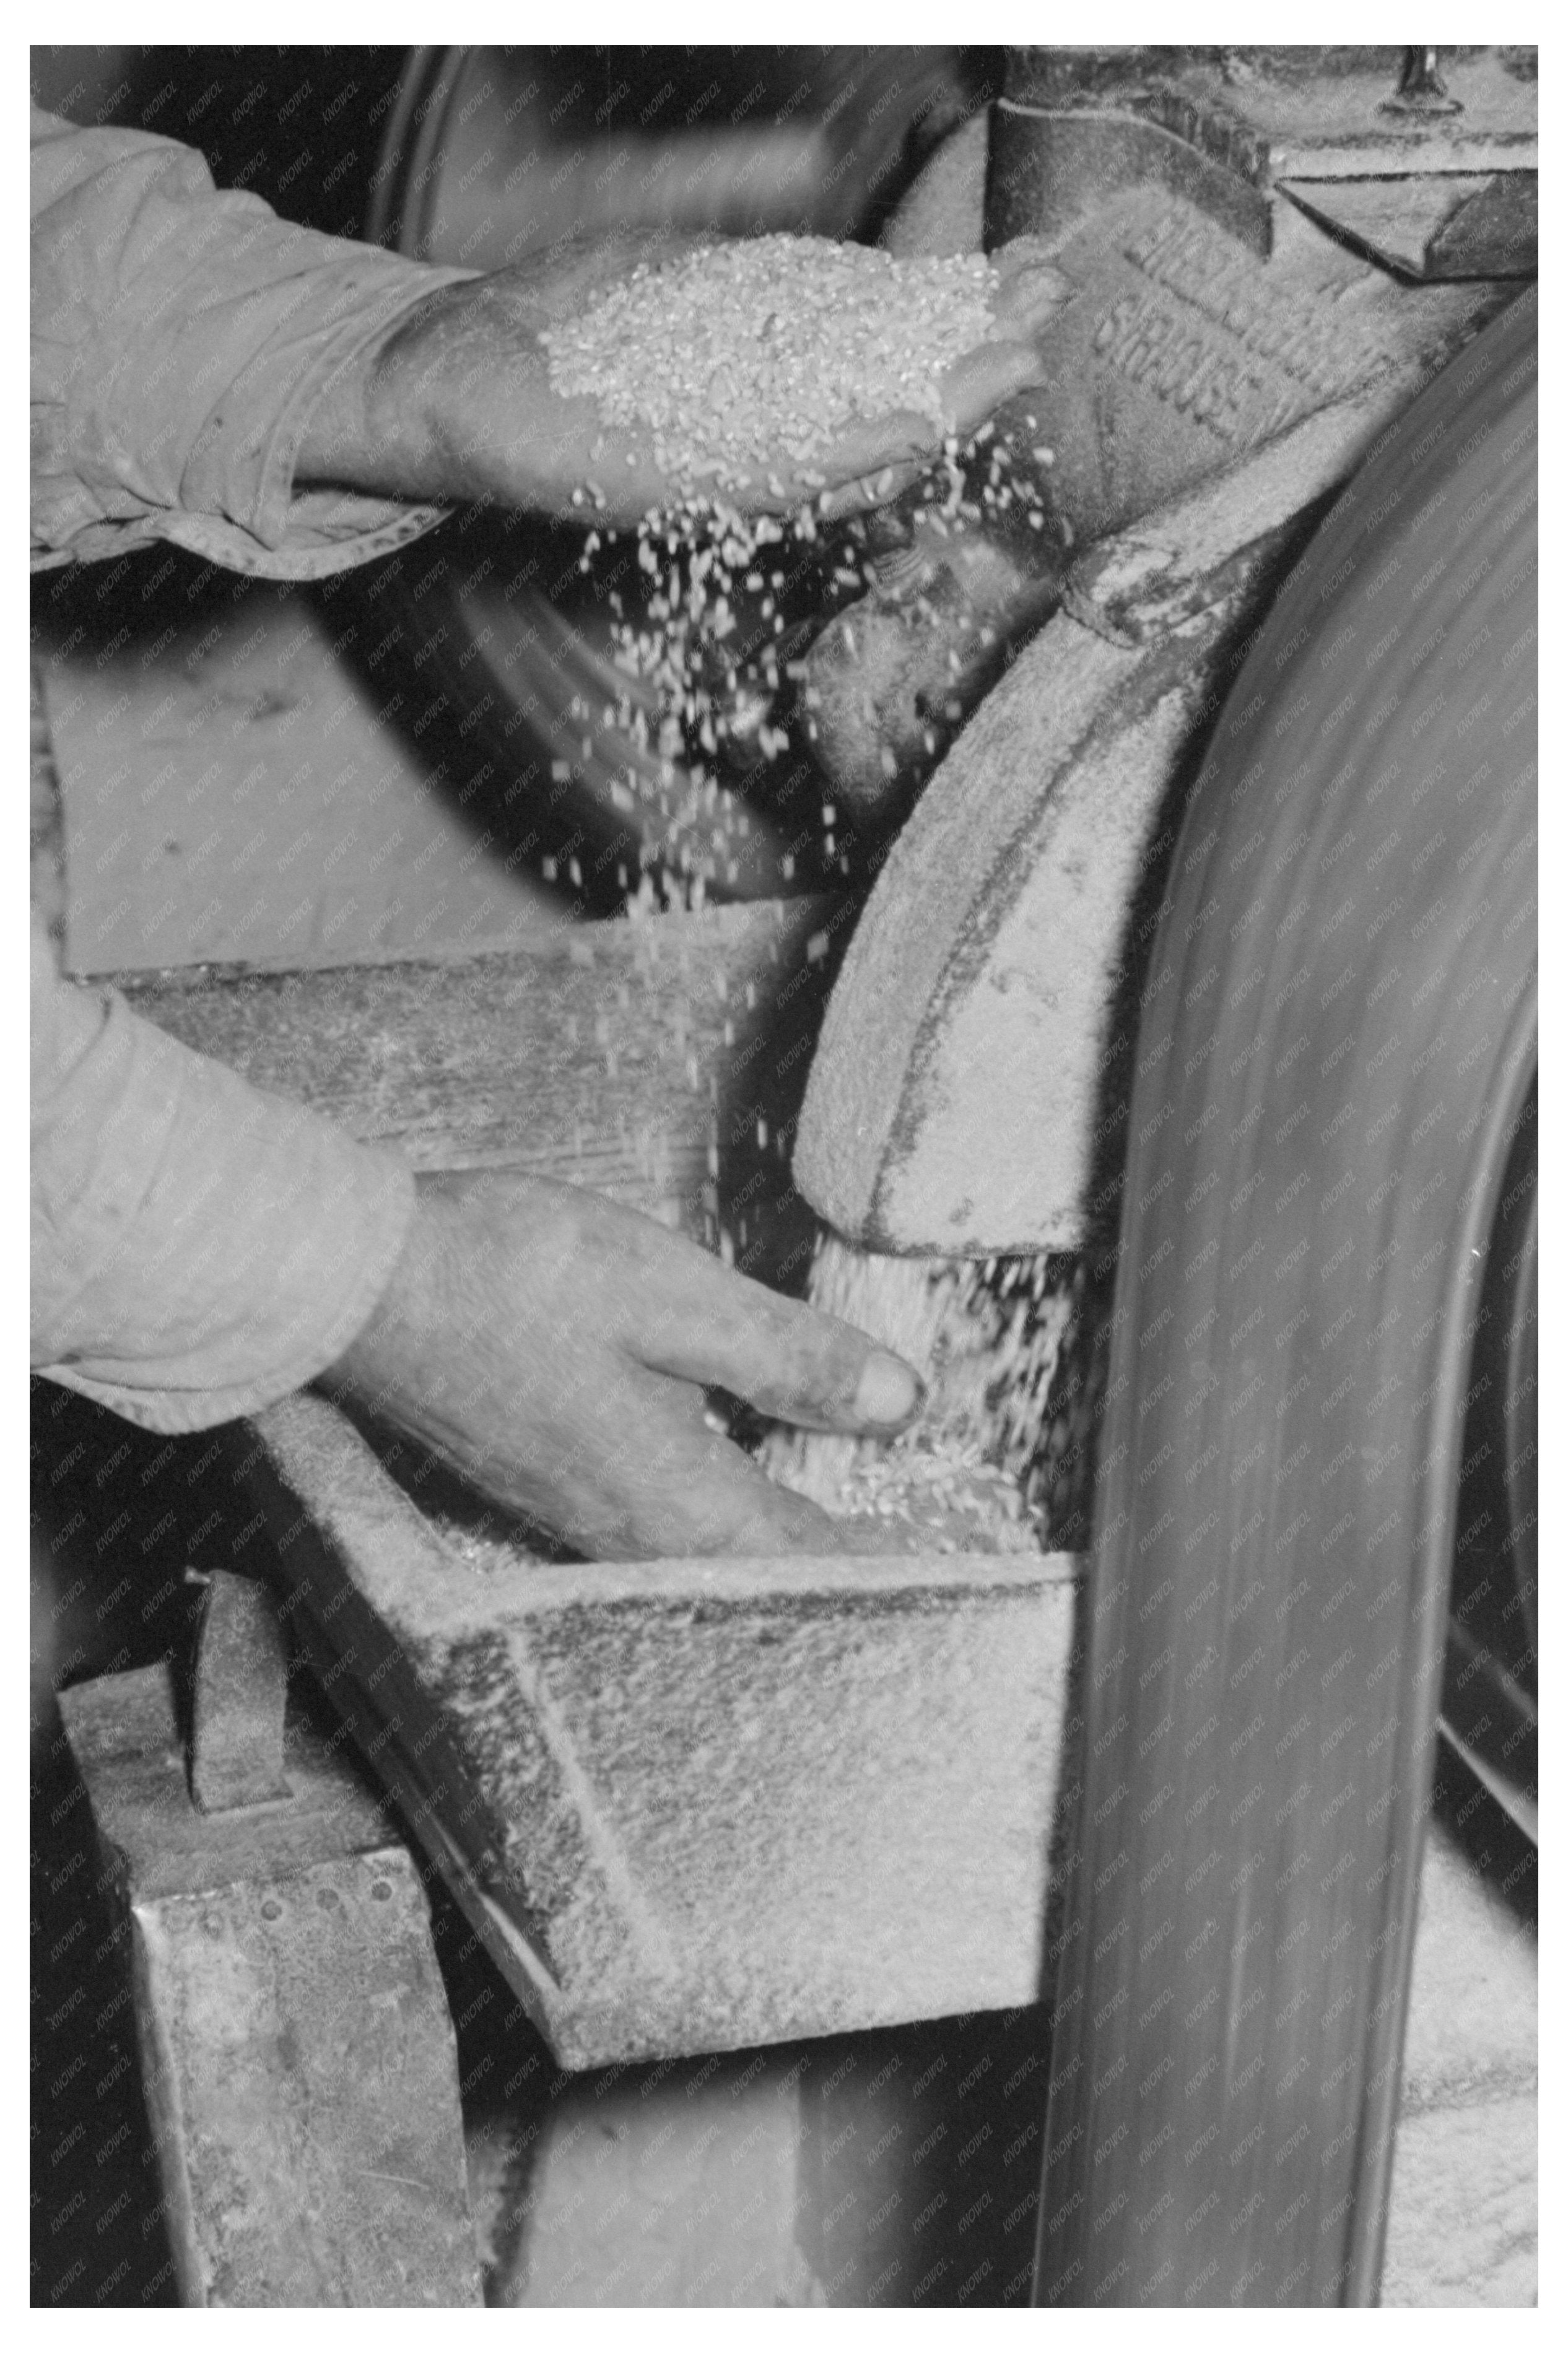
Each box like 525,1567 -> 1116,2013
325,1172 -> 923,1560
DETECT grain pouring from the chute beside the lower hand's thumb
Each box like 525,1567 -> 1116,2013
758,1235 -> 1071,1553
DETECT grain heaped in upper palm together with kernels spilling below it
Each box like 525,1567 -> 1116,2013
541,235 -> 1050,911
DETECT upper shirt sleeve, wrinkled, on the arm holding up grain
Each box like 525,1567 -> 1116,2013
30,108 -> 476,579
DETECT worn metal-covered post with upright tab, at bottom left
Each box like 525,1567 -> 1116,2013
59,1656 -> 481,2308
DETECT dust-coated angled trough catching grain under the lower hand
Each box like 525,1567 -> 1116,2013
237,1398 -> 1076,2066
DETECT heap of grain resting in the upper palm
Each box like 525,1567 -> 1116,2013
541,235 -> 998,485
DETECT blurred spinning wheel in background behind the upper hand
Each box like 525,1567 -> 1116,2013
365,47 -> 998,911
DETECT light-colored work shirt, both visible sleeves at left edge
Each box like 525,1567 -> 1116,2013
30,108 -> 473,1430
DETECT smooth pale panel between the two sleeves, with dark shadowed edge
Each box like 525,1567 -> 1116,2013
33,546 -> 560,974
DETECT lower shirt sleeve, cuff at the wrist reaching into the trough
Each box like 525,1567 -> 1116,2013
30,915 -> 414,1433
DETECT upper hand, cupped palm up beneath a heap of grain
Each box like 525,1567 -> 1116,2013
299,235 -> 1066,524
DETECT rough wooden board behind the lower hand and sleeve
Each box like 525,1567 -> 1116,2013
120,899 -> 845,1264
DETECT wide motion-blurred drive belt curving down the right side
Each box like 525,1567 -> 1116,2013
1039,297 -> 1535,2303
